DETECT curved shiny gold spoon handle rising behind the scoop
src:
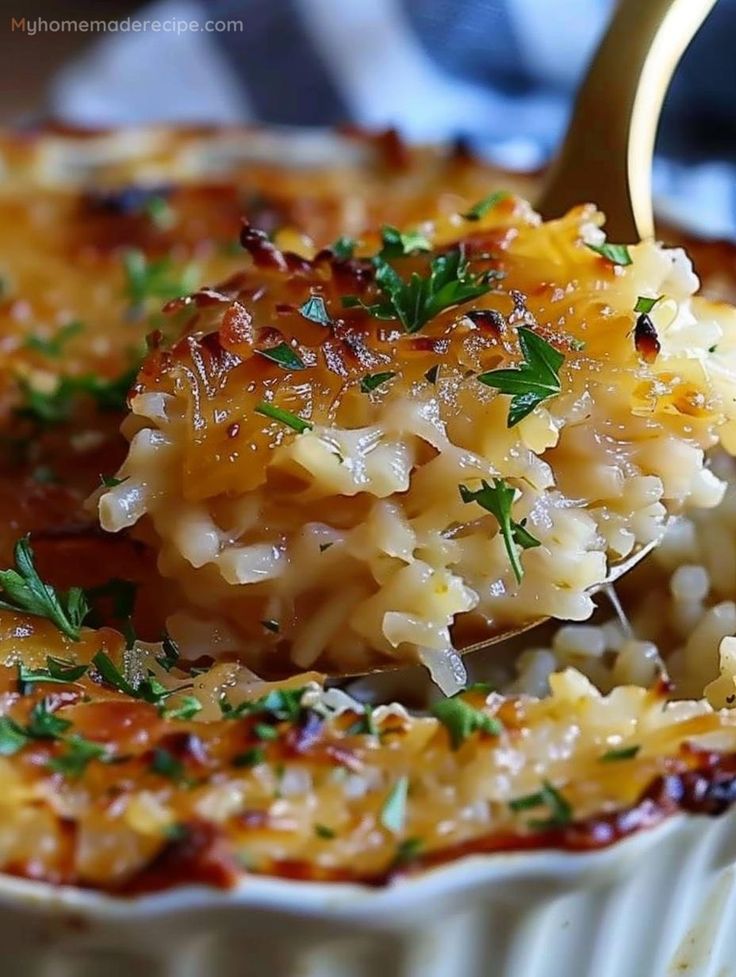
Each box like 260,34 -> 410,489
537,0 -> 716,242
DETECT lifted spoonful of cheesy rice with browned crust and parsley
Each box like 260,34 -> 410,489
98,194 -> 736,691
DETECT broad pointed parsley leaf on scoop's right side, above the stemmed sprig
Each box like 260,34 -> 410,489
478,326 -> 565,427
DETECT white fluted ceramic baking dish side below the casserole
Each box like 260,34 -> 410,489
0,813 -> 736,977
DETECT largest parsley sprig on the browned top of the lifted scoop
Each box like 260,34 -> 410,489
342,245 -> 491,333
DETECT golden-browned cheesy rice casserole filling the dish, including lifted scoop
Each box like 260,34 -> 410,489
0,131 -> 736,912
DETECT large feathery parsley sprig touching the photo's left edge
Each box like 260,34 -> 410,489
0,536 -> 89,641
